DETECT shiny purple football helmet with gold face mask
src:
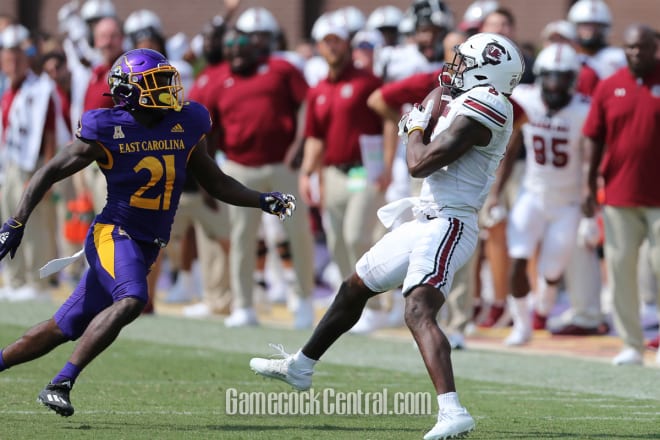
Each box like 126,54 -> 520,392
108,49 -> 183,111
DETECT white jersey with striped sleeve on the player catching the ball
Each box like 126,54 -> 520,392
420,87 -> 513,217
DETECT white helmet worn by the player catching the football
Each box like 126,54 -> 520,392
440,32 -> 525,94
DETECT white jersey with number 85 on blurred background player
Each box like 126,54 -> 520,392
512,85 -> 589,206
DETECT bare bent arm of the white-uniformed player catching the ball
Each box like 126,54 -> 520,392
406,115 -> 491,178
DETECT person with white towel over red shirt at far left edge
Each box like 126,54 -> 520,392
0,25 -> 63,301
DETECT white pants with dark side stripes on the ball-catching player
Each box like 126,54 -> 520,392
355,215 -> 479,296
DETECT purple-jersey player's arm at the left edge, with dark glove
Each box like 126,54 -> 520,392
0,139 -> 105,260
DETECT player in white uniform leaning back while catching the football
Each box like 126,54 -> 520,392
250,33 -> 524,440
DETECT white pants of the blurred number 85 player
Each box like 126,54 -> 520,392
507,191 -> 581,280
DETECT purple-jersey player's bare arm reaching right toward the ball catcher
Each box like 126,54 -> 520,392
188,138 -> 296,220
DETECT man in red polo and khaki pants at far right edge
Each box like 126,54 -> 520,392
583,24 -> 660,365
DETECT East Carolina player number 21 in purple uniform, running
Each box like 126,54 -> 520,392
0,49 -> 295,417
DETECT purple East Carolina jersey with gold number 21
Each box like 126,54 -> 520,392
76,102 -> 211,245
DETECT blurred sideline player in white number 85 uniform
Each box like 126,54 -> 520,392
494,43 -> 589,345
